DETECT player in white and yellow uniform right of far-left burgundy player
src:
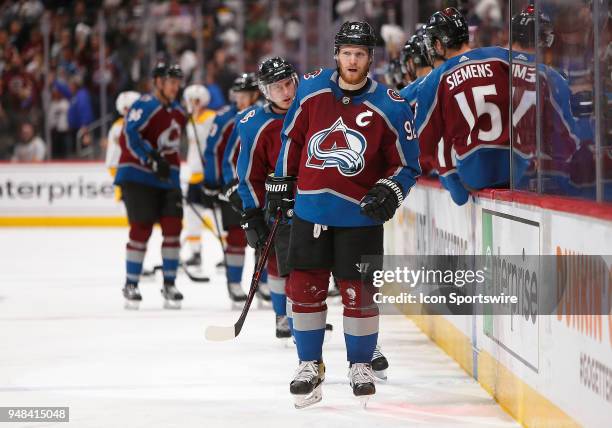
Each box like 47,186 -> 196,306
183,85 -> 215,266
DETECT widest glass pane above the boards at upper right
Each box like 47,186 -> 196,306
535,0 -> 596,199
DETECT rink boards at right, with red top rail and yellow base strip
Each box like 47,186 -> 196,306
385,181 -> 612,427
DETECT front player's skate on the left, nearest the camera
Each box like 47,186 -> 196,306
289,361 -> 325,409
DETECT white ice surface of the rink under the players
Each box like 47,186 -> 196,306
0,228 -> 518,428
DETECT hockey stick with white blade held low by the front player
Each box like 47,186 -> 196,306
205,211 -> 281,342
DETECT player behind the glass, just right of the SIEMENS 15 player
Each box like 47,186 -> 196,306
512,5 -> 580,195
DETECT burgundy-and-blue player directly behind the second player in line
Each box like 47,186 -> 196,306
204,73 -> 259,302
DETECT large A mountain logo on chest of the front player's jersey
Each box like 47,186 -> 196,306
306,118 -> 367,177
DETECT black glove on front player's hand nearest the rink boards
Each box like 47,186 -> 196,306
360,178 -> 404,222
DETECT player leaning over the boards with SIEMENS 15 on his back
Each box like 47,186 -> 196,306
416,8 -> 512,205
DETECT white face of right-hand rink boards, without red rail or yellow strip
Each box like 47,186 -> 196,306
386,185 -> 612,427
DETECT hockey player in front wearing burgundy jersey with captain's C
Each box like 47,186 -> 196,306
268,22 -> 420,408
